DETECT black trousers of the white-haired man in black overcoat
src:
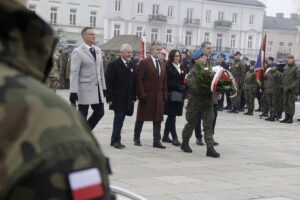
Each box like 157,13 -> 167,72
111,111 -> 125,144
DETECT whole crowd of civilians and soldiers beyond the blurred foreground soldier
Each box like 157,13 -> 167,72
48,27 -> 300,157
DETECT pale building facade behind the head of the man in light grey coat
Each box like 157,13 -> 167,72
27,0 -> 105,48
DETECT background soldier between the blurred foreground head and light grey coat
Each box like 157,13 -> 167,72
47,50 -> 62,91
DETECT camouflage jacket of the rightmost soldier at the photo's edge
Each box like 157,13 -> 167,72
282,64 -> 300,93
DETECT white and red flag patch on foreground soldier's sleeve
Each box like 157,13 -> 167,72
68,168 -> 104,200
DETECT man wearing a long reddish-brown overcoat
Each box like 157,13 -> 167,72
133,42 -> 167,149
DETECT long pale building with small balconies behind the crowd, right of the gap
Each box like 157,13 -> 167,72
104,0 -> 265,57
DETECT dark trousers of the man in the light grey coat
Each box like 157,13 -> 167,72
78,103 -> 104,130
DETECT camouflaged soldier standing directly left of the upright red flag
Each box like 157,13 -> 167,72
244,61 -> 257,115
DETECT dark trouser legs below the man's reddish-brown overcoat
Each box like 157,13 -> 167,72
134,120 -> 161,143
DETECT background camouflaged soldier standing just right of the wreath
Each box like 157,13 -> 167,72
228,51 -> 246,113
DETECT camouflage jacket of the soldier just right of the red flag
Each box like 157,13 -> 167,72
264,69 -> 282,94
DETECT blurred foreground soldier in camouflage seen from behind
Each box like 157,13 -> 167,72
0,0 -> 113,200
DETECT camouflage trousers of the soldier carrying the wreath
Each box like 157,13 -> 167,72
182,99 -> 214,148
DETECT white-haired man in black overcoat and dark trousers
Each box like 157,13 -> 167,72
105,44 -> 136,149
